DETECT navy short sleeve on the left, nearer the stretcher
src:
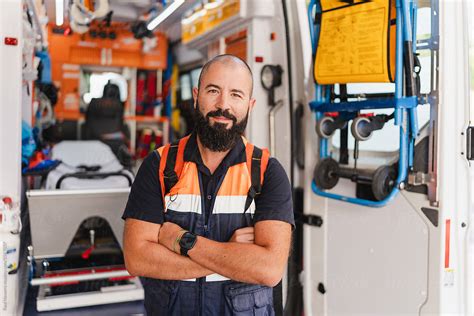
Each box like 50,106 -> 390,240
122,151 -> 164,224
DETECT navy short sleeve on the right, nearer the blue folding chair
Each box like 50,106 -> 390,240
254,158 -> 295,228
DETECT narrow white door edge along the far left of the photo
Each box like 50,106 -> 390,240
0,0 -> 23,315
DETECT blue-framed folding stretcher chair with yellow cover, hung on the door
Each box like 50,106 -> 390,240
308,0 -> 429,207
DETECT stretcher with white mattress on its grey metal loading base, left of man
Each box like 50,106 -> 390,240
27,141 -> 144,311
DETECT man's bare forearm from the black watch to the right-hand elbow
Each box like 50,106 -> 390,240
188,237 -> 283,286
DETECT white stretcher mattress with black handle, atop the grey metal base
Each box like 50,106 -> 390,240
46,140 -> 133,190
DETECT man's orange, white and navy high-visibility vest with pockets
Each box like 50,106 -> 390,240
148,136 -> 274,315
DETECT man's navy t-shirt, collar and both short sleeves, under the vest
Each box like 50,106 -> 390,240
122,135 -> 295,228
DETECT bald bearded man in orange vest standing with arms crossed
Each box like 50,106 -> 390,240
122,55 -> 294,316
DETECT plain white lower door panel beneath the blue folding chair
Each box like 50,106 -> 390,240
325,183 -> 429,315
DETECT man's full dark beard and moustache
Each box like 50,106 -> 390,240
194,104 -> 249,152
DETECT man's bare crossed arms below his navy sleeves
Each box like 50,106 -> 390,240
124,218 -> 291,286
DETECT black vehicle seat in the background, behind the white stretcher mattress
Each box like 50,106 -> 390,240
82,81 -> 131,166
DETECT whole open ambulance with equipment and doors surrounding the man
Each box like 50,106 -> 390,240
0,0 -> 474,315
